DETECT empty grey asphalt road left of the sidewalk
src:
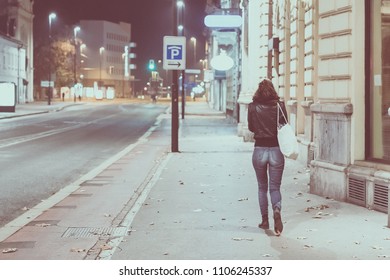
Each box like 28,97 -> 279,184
0,104 -> 167,226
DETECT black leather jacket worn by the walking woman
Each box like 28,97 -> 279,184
248,101 -> 287,147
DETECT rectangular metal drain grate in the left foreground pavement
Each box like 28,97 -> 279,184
62,227 -> 127,238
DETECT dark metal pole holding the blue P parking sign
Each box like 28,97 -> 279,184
171,0 -> 179,153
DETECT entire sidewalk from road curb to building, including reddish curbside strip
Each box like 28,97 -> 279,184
0,102 -> 390,260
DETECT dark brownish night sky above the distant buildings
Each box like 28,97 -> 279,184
34,0 -> 206,89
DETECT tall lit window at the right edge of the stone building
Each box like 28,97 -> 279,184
366,0 -> 390,162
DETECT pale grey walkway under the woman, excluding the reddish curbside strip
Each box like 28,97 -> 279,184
112,107 -> 390,260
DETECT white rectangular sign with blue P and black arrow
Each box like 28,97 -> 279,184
163,36 -> 186,70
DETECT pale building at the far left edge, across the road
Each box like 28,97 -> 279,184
0,0 -> 34,103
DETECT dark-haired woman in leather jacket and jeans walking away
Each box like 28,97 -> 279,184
248,79 -> 287,235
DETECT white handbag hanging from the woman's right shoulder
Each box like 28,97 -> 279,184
277,103 -> 299,159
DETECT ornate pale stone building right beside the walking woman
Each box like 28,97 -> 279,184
238,0 -> 390,222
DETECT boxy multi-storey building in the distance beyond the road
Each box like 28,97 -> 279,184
78,20 -> 133,97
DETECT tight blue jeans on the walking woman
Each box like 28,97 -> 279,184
252,147 -> 284,216
